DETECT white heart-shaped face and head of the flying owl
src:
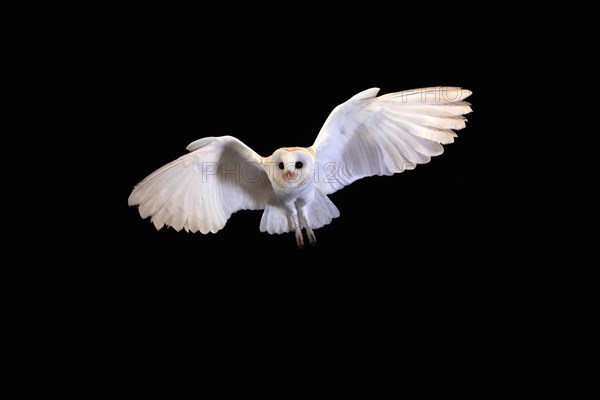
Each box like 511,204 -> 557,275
265,147 -> 314,188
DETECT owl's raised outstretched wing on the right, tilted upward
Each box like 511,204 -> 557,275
312,86 -> 472,194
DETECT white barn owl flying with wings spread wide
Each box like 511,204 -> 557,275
128,86 -> 472,248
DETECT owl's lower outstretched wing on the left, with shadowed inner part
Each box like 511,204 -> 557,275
129,136 -> 273,233
